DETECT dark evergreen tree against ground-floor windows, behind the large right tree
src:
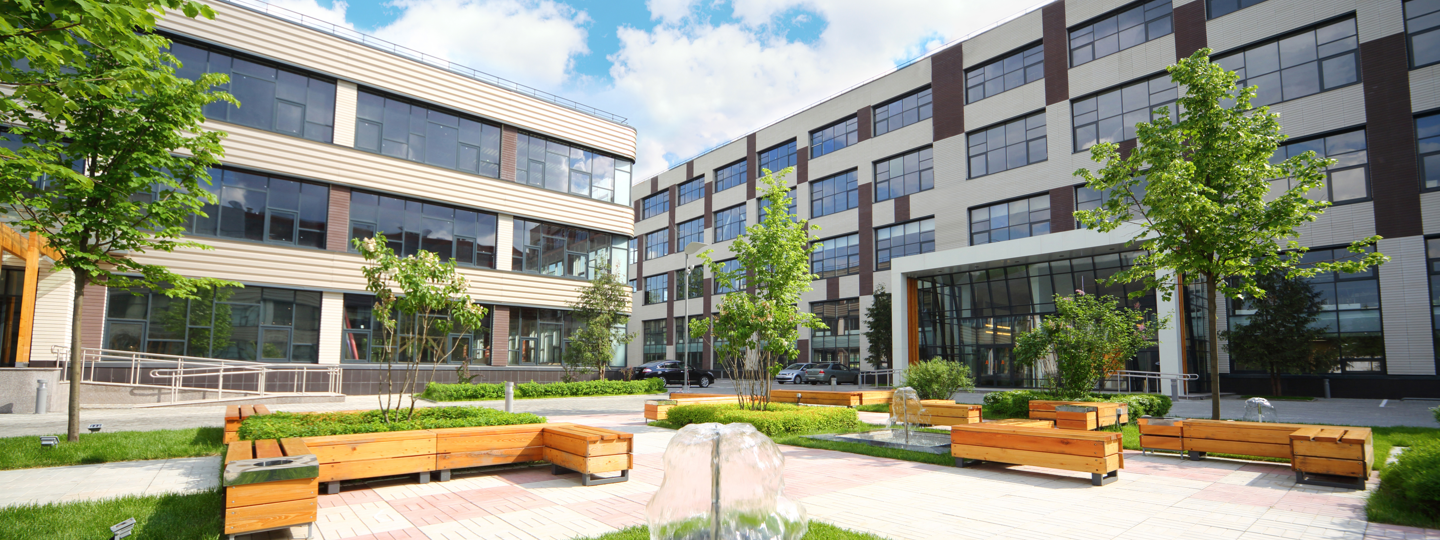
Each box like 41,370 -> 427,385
1220,272 -> 1339,396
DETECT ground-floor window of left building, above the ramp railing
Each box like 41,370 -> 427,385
104,287 -> 320,363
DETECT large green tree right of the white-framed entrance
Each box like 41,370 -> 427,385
1076,49 -> 1388,419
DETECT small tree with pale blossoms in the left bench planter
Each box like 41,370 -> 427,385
351,233 -> 485,423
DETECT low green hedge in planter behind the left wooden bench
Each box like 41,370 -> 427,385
239,408 -> 544,441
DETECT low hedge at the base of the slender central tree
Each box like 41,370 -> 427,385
667,403 -> 865,436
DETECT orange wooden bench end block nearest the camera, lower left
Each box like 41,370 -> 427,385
225,439 -> 320,539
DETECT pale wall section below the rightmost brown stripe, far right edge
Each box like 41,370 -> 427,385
1378,236 -> 1436,374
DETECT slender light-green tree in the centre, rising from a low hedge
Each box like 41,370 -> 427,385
690,167 -> 827,409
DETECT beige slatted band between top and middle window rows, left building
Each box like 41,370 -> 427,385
207,122 -> 635,235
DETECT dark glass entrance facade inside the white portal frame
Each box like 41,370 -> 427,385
919,252 -> 1159,386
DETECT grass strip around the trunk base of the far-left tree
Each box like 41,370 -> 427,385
0,428 -> 225,472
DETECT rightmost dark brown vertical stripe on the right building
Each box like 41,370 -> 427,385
1359,33 -> 1424,238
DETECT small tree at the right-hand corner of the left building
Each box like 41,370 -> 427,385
560,268 -> 635,383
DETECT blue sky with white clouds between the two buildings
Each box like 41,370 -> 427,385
259,0 -> 1040,180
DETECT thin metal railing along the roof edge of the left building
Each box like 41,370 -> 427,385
213,0 -> 625,124
